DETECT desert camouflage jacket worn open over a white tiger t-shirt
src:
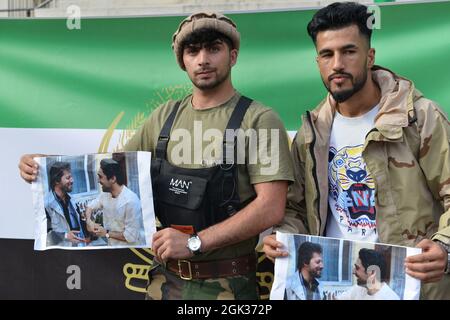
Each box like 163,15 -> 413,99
275,67 -> 450,299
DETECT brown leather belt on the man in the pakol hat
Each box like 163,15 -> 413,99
166,254 -> 256,280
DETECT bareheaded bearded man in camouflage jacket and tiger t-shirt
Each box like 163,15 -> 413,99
264,3 -> 450,299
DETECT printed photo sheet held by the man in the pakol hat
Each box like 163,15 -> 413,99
31,152 -> 156,250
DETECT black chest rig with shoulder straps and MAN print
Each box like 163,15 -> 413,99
151,96 -> 252,233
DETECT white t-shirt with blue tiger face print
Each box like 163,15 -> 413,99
326,106 -> 379,242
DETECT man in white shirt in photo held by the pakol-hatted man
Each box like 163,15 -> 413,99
86,159 -> 145,246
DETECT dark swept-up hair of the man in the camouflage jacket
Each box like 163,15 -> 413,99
307,2 -> 373,47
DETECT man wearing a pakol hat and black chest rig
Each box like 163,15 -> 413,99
19,13 -> 293,299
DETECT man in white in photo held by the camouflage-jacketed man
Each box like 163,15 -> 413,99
336,248 -> 400,300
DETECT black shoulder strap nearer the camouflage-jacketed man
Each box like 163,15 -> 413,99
222,96 -> 253,164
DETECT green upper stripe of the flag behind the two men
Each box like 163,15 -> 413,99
0,2 -> 450,130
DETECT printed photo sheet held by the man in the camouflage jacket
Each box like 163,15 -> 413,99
270,232 -> 421,300
